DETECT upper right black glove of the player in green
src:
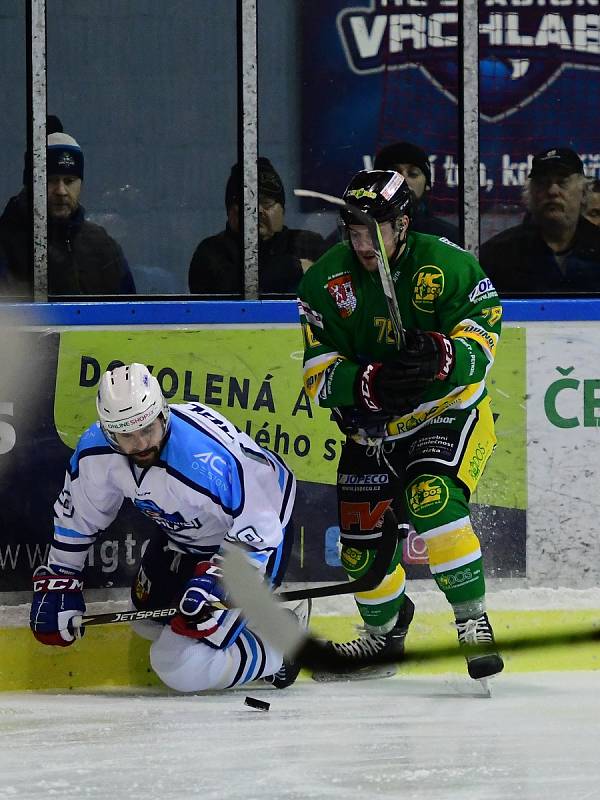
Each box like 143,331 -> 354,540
393,330 -> 455,381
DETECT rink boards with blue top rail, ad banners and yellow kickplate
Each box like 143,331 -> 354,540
0,301 -> 600,690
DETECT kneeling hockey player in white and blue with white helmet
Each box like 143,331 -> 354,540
30,364 -> 308,691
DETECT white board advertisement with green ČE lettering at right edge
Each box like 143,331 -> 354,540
527,322 -> 600,589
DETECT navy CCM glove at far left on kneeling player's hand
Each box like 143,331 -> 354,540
29,566 -> 85,647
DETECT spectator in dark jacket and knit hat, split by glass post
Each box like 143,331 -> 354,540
189,157 -> 326,297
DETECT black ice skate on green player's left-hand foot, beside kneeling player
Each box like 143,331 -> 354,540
313,597 -> 415,681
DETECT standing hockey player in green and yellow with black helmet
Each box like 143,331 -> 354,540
299,170 -> 503,678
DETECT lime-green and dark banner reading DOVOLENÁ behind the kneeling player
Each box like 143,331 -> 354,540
0,326 -> 526,591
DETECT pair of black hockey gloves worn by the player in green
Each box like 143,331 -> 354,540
354,330 -> 454,414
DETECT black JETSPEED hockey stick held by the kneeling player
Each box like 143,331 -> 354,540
75,509 -> 398,627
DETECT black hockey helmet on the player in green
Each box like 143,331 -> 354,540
341,169 -> 413,225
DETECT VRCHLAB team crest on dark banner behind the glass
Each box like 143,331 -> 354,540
337,0 -> 600,122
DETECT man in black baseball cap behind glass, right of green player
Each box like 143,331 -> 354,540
479,148 -> 600,294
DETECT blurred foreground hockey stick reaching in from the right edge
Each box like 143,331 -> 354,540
223,547 -> 600,672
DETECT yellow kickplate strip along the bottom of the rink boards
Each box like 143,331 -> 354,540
0,610 -> 600,691
